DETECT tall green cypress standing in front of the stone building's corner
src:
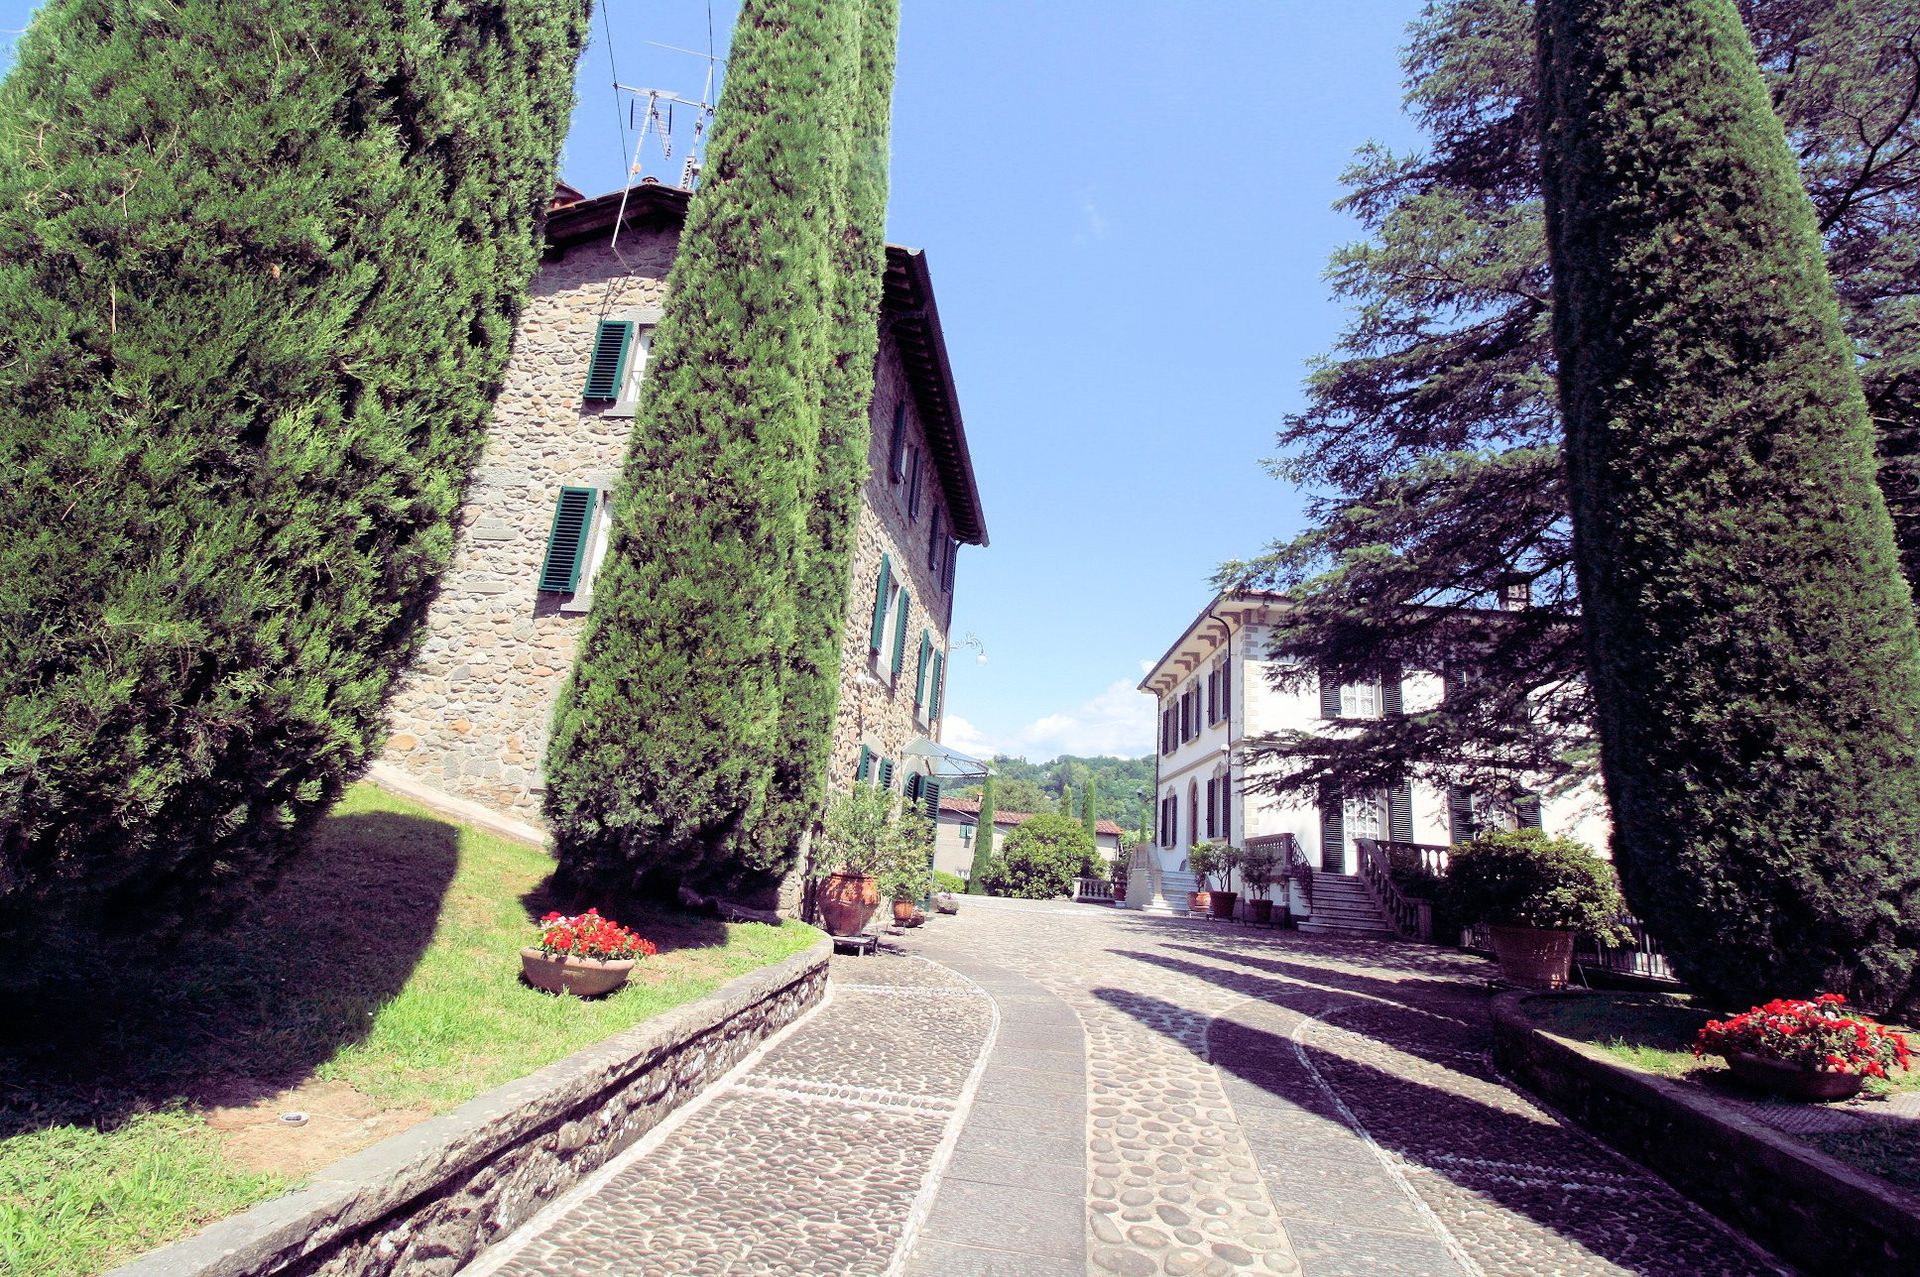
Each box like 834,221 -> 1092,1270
547,0 -> 891,894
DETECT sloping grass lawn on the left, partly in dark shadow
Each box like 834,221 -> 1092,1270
0,785 -> 818,1275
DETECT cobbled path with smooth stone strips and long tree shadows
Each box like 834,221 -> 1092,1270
460,899 -> 1782,1277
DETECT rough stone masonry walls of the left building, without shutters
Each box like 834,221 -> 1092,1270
382,229 -> 952,825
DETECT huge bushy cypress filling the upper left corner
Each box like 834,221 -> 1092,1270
0,0 -> 588,929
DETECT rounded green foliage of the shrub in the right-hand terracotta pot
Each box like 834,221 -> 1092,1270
1442,830 -> 1628,943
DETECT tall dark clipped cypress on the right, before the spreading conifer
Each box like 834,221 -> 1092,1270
1538,0 -> 1920,1008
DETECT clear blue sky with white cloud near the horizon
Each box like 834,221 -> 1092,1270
0,0 -> 1419,760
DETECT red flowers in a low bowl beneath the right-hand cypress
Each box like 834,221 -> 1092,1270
1693,993 -> 1908,1100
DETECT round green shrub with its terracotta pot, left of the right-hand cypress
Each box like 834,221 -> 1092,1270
1446,830 -> 1628,989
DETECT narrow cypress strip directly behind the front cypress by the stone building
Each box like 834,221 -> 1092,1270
744,0 -> 899,885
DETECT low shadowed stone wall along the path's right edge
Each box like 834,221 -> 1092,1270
1494,993 -> 1920,1277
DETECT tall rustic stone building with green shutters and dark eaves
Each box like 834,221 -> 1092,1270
382,184 -> 987,841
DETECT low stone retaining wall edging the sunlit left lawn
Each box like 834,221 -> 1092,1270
111,935 -> 831,1277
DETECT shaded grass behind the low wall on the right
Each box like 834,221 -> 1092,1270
1526,993 -> 1920,1193
